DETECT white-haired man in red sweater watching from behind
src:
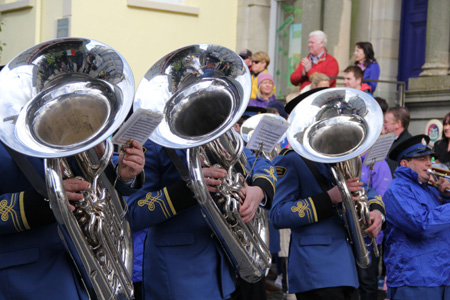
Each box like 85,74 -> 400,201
291,30 -> 339,91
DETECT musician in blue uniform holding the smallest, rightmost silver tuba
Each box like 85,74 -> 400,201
270,90 -> 384,300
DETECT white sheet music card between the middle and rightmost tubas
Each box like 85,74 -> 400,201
247,117 -> 289,152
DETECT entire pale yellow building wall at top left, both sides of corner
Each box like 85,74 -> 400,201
0,0 -> 237,85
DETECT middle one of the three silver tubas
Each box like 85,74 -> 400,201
134,44 -> 271,282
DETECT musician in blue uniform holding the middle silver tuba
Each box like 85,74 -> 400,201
127,137 -> 276,300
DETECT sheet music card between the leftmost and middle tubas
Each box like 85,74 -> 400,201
112,108 -> 163,145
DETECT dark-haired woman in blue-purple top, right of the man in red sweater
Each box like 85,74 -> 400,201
353,42 -> 380,93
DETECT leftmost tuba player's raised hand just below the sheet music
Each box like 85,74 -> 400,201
119,141 -> 145,181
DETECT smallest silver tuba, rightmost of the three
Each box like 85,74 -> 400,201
287,88 -> 383,268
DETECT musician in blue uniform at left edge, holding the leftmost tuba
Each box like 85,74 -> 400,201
0,143 -> 144,300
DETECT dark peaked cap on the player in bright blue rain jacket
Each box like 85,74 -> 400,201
389,134 -> 434,162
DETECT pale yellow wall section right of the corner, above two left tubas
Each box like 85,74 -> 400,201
72,0 -> 237,83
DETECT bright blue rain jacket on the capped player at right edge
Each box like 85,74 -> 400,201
384,167 -> 450,287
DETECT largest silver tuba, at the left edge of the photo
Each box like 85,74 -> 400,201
0,38 -> 134,299
